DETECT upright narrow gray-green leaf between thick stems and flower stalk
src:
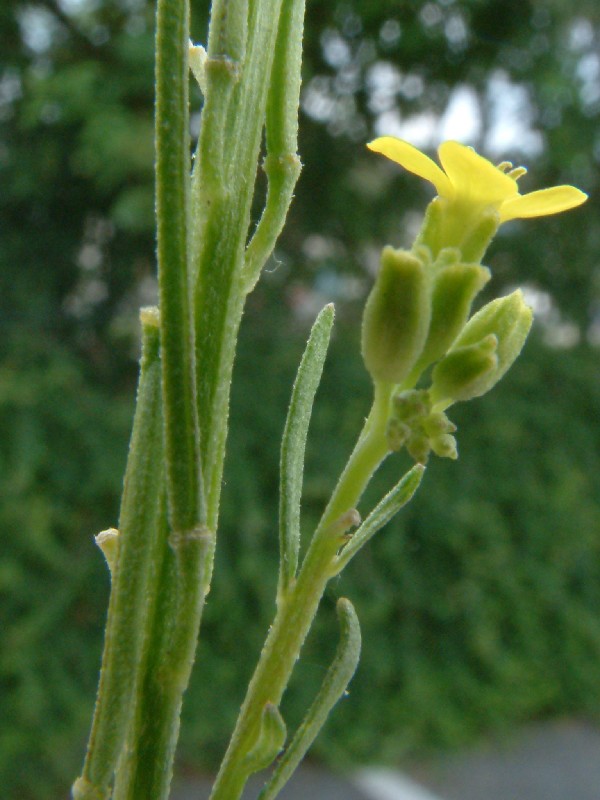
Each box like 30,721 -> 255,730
277,304 -> 334,598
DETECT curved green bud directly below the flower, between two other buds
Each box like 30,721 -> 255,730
417,264 -> 490,371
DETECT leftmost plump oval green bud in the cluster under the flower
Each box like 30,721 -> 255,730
362,247 -> 431,383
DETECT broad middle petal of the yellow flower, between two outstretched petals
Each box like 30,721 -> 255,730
438,141 -> 519,206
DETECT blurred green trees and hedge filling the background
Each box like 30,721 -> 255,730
0,0 -> 600,800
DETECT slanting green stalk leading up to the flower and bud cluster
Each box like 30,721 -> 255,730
211,385 -> 393,800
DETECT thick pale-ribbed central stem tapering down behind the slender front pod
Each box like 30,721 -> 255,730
191,0 -> 282,510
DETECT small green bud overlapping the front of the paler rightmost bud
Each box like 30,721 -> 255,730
431,334 -> 498,402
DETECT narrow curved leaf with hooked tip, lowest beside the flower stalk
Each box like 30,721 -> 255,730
259,597 -> 361,800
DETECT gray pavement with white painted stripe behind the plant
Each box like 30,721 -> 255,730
173,720 -> 600,800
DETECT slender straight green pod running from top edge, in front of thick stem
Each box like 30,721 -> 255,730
156,0 -> 203,532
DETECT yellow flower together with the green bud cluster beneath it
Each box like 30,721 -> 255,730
362,137 -> 586,463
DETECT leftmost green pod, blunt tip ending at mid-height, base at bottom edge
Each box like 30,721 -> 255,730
73,317 -> 164,800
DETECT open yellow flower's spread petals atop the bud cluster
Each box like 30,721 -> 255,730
367,136 -> 587,223
